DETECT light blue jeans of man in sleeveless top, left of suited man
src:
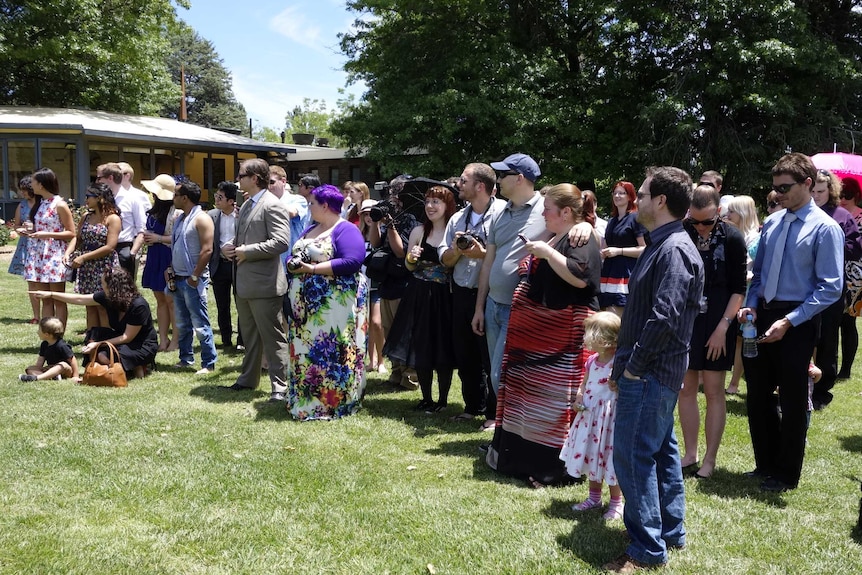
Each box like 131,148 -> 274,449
174,277 -> 218,369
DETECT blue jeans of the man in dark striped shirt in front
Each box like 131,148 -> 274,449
614,375 -> 685,565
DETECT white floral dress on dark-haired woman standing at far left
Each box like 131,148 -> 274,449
24,196 -> 72,284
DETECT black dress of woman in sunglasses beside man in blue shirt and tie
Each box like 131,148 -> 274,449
685,222 -> 747,371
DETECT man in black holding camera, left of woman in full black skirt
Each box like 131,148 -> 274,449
368,175 -> 419,389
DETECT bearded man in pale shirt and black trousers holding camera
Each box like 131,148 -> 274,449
440,164 -> 506,421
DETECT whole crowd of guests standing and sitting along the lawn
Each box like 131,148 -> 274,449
10,153 -> 862,572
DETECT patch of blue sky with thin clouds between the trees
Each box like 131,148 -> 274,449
177,0 -> 363,132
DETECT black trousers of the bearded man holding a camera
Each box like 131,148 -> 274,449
452,283 -> 497,419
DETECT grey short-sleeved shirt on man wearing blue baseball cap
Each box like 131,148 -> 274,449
488,192 -> 547,305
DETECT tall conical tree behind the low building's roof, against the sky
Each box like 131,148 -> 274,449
161,21 -> 248,130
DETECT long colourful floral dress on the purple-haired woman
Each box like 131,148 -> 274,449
287,235 -> 367,421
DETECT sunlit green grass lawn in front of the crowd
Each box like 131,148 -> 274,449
0,264 -> 862,575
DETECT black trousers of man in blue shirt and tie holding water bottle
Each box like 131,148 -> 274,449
742,307 -> 818,486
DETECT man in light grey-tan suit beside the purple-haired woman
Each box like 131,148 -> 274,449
222,158 -> 290,401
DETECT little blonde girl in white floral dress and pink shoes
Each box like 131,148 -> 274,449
560,311 -> 623,520
